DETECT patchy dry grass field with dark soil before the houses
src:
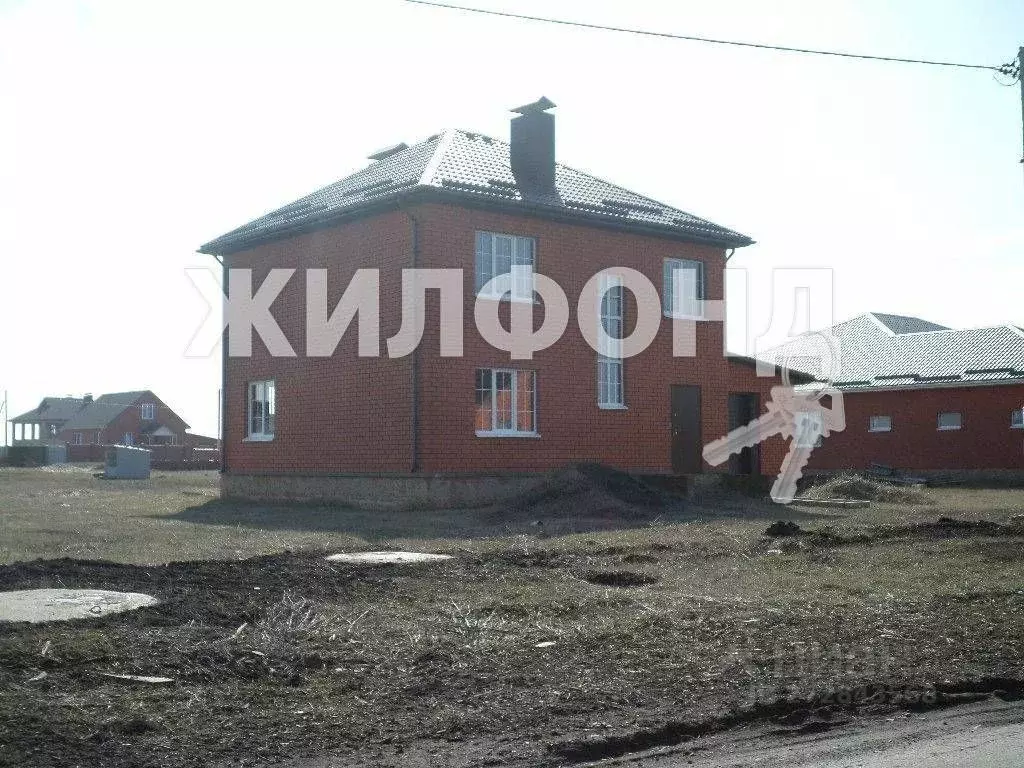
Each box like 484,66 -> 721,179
0,470 -> 1024,767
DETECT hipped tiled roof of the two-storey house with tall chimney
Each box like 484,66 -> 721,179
200,130 -> 753,254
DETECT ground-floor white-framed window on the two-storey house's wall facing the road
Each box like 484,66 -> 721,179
475,368 -> 537,437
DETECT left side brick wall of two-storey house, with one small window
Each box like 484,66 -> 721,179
223,212 -> 412,473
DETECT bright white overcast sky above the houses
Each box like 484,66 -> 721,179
0,0 -> 1024,434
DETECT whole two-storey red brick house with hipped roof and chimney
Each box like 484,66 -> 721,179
201,99 -> 783,505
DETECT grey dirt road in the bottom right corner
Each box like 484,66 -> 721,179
597,699 -> 1024,768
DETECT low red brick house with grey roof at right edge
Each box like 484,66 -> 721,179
766,312 -> 1024,473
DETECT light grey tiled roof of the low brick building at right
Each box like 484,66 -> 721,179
764,313 -> 1024,388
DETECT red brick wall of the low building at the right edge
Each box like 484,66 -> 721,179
809,384 -> 1024,470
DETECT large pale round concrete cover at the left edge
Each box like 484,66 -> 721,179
0,590 -> 159,623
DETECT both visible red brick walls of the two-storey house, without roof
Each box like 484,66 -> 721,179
224,205 -> 784,473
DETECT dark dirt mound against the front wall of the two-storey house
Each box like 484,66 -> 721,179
498,464 -> 680,520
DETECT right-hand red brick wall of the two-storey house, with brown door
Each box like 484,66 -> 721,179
407,205 -> 777,472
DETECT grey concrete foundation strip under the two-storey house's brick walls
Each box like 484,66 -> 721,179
220,473 -> 548,511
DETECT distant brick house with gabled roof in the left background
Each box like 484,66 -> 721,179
57,390 -> 188,445
